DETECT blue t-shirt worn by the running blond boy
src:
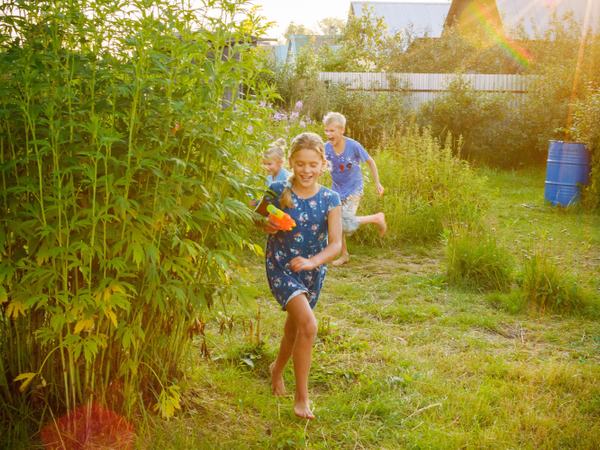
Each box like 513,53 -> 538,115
325,137 -> 370,200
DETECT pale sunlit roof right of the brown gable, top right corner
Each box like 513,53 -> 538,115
496,0 -> 600,39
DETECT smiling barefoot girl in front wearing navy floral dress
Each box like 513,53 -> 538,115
257,132 -> 342,419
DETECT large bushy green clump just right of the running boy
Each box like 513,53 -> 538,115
353,126 -> 486,245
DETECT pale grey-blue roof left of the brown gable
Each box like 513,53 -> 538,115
350,0 -> 450,38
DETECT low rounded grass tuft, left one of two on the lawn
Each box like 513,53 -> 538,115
446,227 -> 514,291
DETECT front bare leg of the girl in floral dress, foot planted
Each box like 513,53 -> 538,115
286,294 -> 317,419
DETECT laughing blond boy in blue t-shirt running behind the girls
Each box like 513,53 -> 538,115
323,112 -> 387,266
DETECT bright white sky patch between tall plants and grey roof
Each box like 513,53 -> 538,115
252,0 -> 445,39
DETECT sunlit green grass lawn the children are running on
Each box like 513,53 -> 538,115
140,171 -> 600,449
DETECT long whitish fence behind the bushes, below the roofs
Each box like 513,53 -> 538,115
319,72 -> 532,107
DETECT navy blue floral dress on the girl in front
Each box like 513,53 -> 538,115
265,182 -> 340,310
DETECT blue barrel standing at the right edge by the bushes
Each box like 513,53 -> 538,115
544,141 -> 590,206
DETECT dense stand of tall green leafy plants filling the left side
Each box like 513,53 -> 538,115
0,0 -> 270,442
